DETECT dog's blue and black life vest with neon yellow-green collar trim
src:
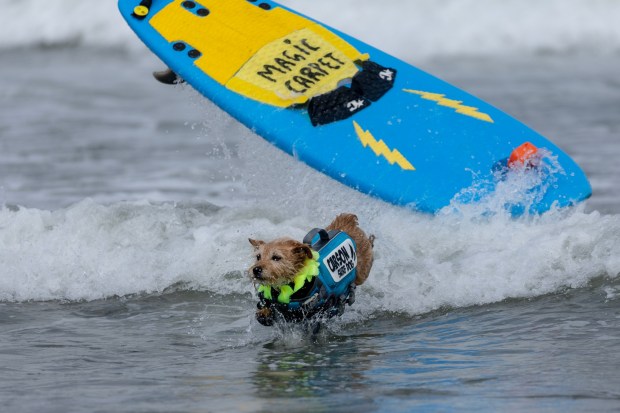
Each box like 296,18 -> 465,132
258,228 -> 357,325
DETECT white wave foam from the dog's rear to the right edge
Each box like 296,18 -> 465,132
355,206 -> 620,316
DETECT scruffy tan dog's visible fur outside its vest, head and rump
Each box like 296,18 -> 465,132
248,213 -> 375,325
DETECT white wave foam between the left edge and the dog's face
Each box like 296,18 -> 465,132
0,200 -> 256,301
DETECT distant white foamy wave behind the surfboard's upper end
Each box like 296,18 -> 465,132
0,0 -> 620,59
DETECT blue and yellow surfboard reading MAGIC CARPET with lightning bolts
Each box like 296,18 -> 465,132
118,0 -> 591,215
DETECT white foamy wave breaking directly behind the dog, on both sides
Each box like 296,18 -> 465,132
0,200 -> 620,319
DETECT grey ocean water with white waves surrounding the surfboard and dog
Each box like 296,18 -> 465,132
0,0 -> 620,412
